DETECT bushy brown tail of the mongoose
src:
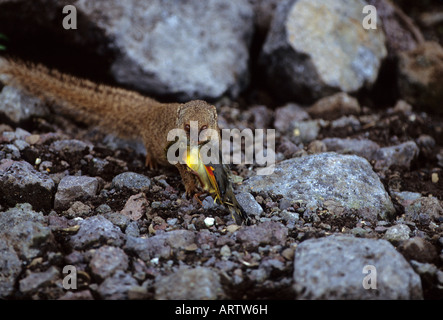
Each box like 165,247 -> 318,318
0,57 -> 161,137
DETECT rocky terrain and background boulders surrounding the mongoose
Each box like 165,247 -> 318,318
0,0 -> 443,299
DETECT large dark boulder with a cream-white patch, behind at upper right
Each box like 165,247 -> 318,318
260,0 -> 387,103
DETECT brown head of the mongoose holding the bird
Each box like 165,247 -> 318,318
176,100 -> 219,143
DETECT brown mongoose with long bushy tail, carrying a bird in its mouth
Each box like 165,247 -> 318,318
0,57 -> 219,196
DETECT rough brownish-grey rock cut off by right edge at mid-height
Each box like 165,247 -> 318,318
405,197 -> 443,225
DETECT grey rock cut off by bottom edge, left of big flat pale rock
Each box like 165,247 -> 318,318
154,267 -> 224,300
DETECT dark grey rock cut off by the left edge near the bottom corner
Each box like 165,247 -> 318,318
0,238 -> 22,299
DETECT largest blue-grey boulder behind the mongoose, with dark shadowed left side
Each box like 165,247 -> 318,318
0,0 -> 254,100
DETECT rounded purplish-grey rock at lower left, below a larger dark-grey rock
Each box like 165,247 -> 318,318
89,246 -> 129,280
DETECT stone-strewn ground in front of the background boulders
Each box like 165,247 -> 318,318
0,91 -> 443,299
